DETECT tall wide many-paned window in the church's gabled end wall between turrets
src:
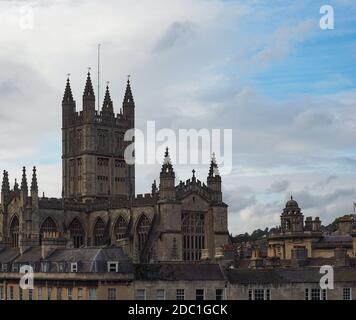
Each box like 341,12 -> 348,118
182,212 -> 205,261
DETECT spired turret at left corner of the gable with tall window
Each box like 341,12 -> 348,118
159,148 -> 176,200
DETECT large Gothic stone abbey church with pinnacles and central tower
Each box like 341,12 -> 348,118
0,73 -> 229,262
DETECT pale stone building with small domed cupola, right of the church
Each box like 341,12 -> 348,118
267,197 -> 356,264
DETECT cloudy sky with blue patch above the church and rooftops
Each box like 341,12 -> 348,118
0,0 -> 356,234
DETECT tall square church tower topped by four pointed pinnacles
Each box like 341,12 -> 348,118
62,72 -> 135,200
